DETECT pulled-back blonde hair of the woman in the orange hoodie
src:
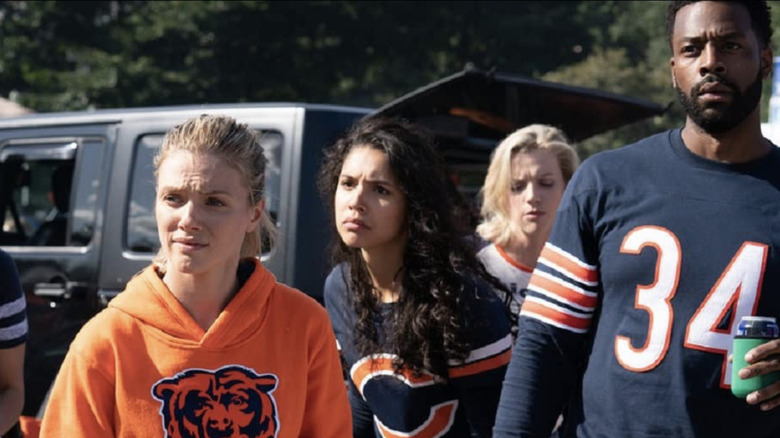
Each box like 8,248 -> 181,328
154,114 -> 277,272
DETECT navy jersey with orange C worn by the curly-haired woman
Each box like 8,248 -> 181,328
324,264 -> 512,438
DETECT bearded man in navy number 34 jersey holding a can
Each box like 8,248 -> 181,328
494,1 -> 780,438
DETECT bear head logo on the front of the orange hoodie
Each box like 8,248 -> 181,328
152,365 -> 279,438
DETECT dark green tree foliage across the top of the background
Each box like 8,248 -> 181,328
0,1 -> 780,155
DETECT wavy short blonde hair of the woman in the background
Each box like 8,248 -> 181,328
477,124 -> 580,245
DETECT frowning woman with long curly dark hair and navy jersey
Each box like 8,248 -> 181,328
320,118 -> 512,438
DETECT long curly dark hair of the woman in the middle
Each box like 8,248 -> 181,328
319,117 -> 504,379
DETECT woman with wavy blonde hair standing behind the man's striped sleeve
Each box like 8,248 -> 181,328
477,124 -> 580,328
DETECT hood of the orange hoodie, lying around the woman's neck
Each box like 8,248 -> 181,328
108,259 -> 277,349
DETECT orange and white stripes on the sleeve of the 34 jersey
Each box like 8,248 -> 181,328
520,243 -> 598,333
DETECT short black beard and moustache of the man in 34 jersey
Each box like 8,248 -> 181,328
674,71 -> 762,134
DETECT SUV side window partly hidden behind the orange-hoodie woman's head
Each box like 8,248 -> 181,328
125,131 -> 283,253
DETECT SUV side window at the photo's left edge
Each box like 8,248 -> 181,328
0,139 -> 104,247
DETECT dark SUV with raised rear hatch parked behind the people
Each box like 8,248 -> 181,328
0,70 -> 663,424
